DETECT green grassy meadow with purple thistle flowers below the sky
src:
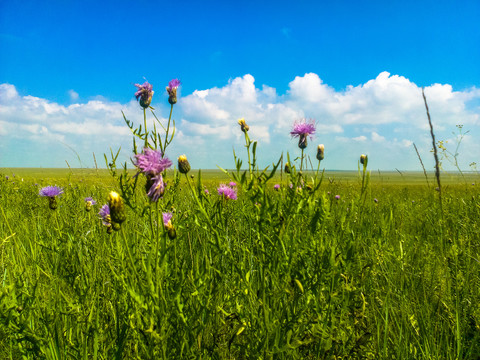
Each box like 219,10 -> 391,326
0,80 -> 480,359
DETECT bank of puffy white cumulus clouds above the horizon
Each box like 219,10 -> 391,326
0,72 -> 480,169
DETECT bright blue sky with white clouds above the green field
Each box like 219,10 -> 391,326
0,0 -> 480,170
